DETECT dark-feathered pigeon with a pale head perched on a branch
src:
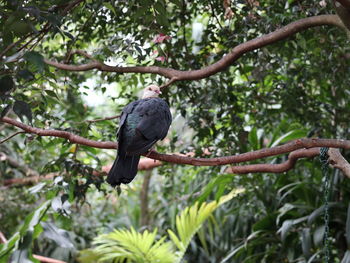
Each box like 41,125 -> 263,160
107,85 -> 172,187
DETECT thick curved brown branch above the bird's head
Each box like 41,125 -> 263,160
45,15 -> 344,82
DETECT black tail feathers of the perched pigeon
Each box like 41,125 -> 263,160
107,155 -> 140,187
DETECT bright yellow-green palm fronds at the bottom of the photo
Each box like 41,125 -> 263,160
80,190 -> 242,263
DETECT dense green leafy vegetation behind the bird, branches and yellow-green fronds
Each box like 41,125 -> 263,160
0,0 -> 350,262
